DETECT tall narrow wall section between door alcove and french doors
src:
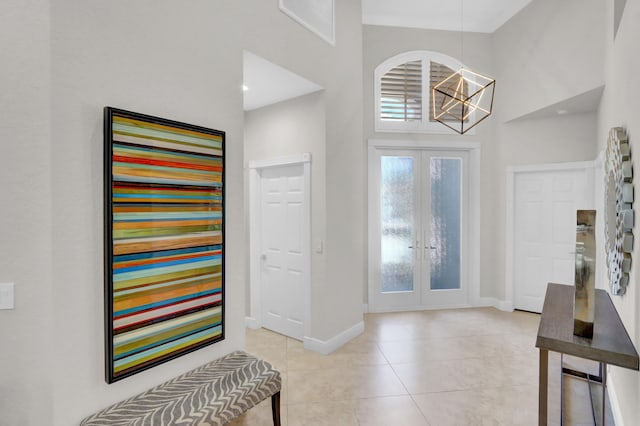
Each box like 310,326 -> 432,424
316,0 -> 366,341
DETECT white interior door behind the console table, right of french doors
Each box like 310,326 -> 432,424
514,168 -> 594,312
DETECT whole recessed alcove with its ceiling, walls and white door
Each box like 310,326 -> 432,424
243,51 -> 326,341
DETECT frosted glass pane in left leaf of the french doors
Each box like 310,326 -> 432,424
380,156 -> 415,293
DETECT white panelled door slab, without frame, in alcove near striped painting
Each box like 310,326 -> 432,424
258,164 -> 310,339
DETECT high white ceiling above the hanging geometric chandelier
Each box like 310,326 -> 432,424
362,0 -> 531,33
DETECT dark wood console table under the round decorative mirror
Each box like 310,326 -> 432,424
536,283 -> 639,425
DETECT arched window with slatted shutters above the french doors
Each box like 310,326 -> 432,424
374,50 -> 462,134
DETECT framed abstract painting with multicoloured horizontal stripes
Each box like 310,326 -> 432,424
105,107 -> 225,383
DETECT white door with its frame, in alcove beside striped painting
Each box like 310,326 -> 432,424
249,153 -> 311,340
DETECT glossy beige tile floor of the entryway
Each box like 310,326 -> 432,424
232,308 -> 613,426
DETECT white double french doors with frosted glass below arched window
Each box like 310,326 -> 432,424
369,149 -> 469,312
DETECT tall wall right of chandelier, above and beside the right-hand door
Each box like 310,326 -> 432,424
490,0 -> 605,303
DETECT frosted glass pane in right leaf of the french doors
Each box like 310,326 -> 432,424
425,157 -> 462,290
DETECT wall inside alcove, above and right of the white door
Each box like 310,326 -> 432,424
244,92 -> 326,322
